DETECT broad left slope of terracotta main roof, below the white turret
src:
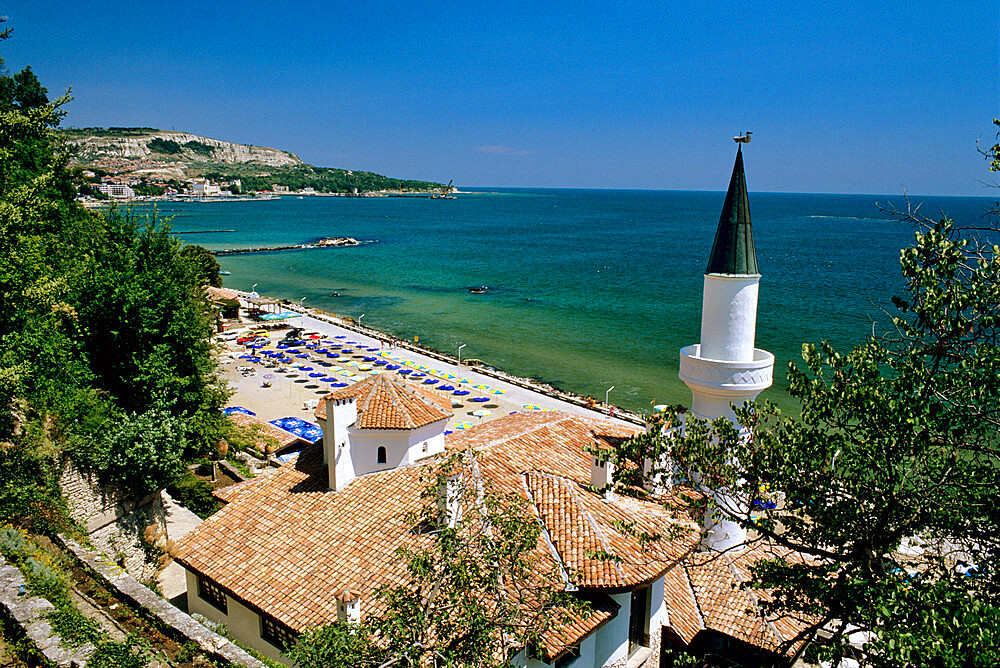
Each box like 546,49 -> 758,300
174,446 -> 425,631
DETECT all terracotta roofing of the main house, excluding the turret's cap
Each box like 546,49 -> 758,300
174,412 -> 796,658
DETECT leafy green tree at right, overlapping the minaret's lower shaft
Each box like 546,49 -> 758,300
616,151 -> 1000,666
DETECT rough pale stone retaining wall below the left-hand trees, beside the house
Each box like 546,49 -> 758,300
59,462 -> 167,580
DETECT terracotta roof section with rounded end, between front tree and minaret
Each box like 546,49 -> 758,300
445,412 -> 699,588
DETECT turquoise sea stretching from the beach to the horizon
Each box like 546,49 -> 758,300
159,187 -> 993,411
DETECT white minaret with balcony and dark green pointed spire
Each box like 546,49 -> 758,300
679,145 -> 774,551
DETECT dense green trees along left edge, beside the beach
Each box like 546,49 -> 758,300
0,28 -> 225,526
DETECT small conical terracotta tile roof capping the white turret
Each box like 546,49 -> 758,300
315,374 -> 454,429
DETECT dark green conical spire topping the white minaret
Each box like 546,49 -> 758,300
705,146 -> 760,275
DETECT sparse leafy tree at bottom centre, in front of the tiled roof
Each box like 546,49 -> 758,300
287,454 -> 586,668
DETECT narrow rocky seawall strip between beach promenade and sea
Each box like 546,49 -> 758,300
230,290 -> 646,426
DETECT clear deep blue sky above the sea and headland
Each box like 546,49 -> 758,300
0,0 -> 1000,197
